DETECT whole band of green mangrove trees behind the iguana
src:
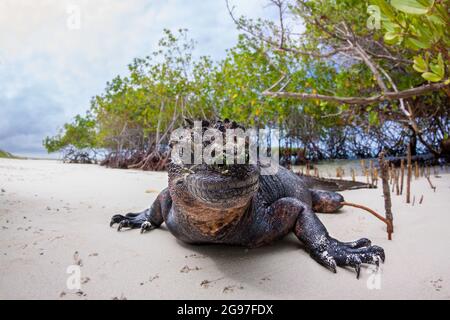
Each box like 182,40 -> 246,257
44,0 -> 450,169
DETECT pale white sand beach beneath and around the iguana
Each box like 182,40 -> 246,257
0,159 -> 450,299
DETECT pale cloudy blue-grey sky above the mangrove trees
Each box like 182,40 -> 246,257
0,0 -> 275,156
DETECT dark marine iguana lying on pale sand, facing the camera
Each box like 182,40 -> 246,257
110,122 -> 385,277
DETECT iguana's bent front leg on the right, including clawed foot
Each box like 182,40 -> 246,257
273,198 -> 385,278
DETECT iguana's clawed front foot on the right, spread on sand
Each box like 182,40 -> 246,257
310,238 -> 385,279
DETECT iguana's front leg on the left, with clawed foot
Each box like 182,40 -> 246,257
110,188 -> 172,233
